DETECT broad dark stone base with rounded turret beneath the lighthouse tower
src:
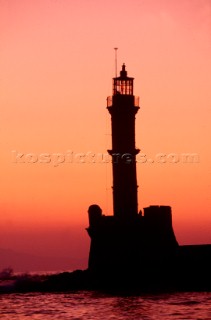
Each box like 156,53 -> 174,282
87,205 -> 178,274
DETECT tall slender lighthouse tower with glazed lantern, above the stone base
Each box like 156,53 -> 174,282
107,64 -> 139,219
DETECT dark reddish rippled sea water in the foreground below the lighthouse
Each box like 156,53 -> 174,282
0,291 -> 211,320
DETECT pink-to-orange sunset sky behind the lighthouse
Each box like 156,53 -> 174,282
0,0 -> 211,270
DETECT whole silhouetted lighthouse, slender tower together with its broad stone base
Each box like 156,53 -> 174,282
87,64 -> 178,274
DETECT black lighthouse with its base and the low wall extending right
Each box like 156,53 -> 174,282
83,59 -> 211,293
